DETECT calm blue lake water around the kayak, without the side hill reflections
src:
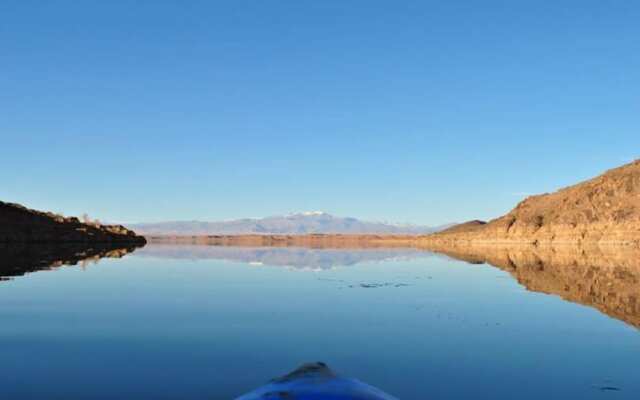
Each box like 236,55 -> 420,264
0,245 -> 640,400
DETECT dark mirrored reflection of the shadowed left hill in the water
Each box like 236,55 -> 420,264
0,243 -> 143,281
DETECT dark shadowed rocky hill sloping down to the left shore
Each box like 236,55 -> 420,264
0,202 -> 146,244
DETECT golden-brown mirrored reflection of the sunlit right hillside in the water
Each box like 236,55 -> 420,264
422,243 -> 640,328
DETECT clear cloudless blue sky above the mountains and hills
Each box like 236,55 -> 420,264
0,0 -> 640,224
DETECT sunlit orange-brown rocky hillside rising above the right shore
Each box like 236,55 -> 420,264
423,160 -> 640,245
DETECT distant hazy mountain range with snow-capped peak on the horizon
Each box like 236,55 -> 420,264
129,211 -> 450,236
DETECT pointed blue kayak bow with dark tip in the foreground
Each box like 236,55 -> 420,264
236,363 -> 397,400
